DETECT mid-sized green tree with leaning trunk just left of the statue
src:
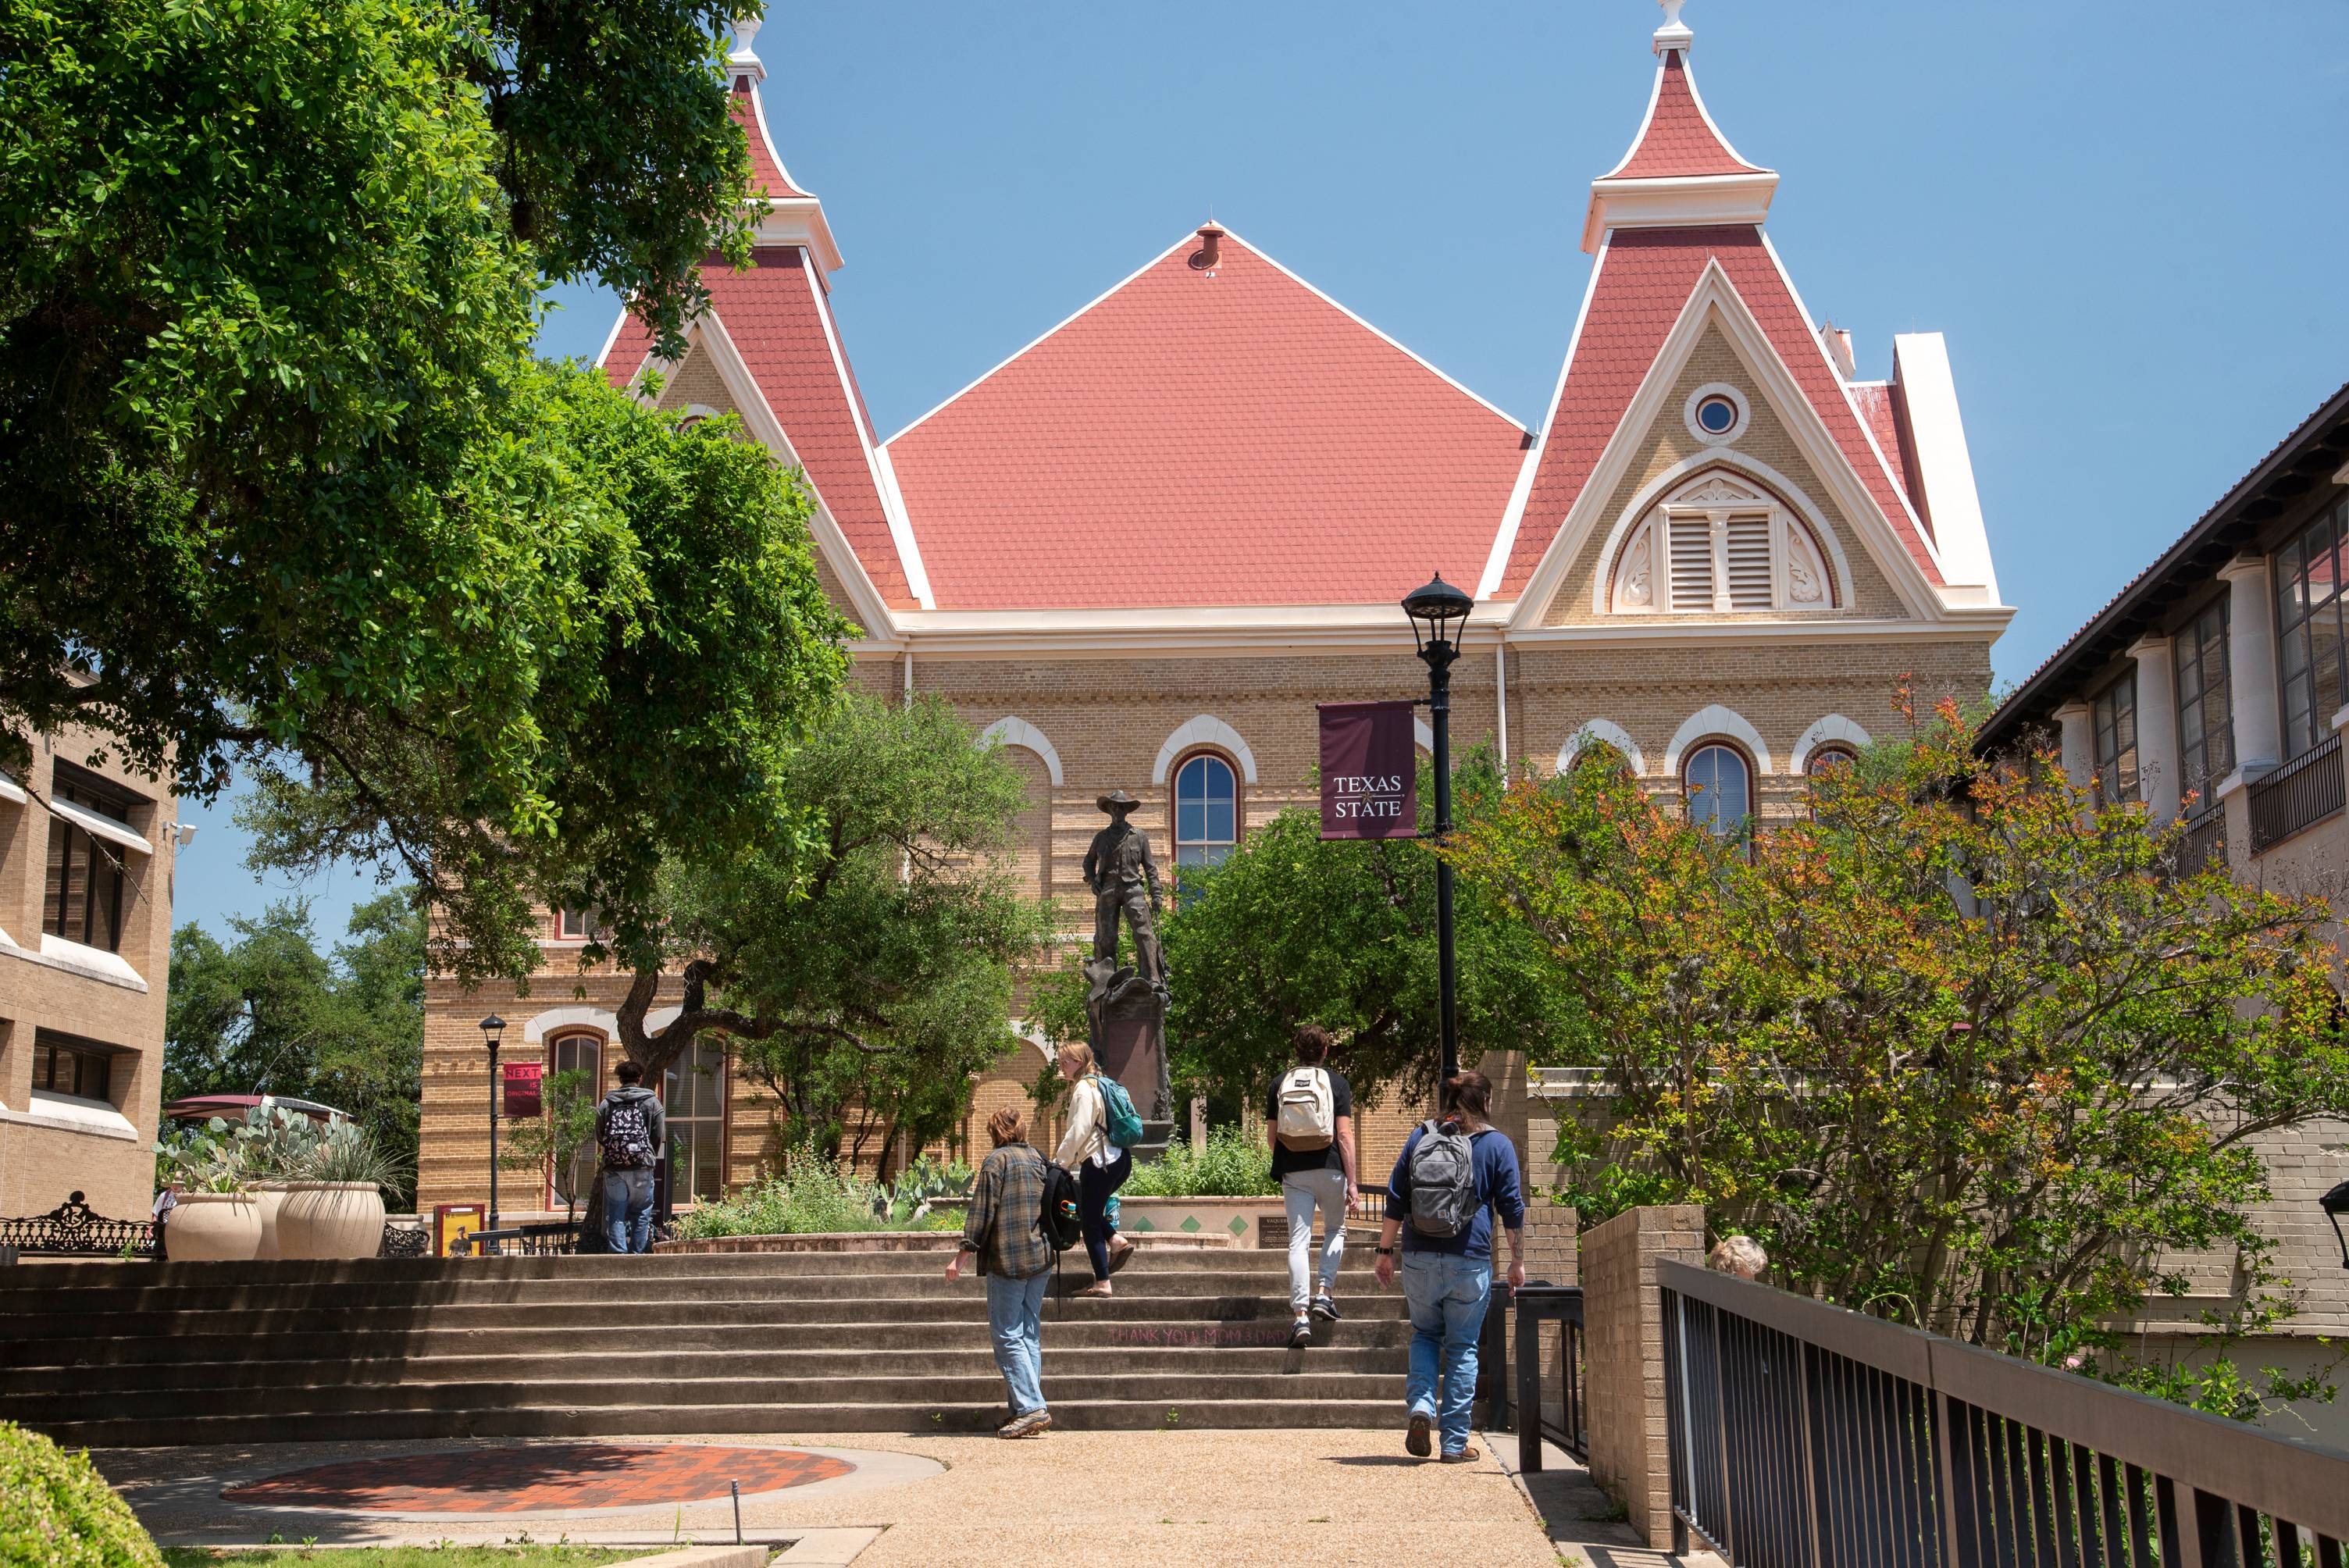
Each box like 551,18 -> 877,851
618,693 -> 1053,1173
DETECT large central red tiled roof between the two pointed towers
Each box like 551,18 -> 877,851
888,235 -> 1524,611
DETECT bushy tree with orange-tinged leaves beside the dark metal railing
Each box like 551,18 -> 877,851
1454,707 -> 2349,1408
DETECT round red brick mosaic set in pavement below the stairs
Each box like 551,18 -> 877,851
221,1444 -> 855,1514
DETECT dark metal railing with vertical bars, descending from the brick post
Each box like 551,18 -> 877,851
1659,1263 -> 2349,1568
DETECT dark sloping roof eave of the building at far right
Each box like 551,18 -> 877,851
1976,385 -> 2349,751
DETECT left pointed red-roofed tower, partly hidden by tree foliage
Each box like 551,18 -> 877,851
597,19 -> 932,632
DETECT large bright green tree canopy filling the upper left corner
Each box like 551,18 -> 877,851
0,0 -> 841,974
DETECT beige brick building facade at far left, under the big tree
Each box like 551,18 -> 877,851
0,730 -> 179,1218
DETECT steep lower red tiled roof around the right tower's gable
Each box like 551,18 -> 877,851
1501,223 -> 1941,599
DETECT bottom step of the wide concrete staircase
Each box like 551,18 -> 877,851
27,1399 -> 1403,1451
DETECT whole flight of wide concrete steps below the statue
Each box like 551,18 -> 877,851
0,1237 -> 1410,1449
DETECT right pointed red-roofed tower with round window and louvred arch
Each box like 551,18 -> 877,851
1477,0 -> 2004,627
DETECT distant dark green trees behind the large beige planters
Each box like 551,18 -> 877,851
162,894 -> 425,1195
